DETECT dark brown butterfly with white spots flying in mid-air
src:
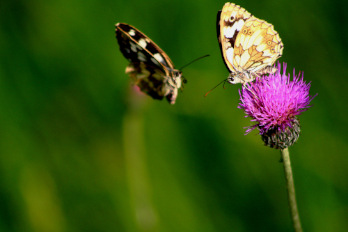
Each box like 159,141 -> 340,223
115,23 -> 184,104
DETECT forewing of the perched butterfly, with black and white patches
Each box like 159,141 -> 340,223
216,2 -> 252,73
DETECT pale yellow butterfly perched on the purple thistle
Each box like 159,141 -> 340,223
216,2 -> 283,84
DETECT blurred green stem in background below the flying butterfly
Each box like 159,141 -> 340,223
123,89 -> 158,232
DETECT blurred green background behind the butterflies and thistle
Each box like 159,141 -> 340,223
0,0 -> 348,232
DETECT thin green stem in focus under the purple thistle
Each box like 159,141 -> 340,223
281,148 -> 302,232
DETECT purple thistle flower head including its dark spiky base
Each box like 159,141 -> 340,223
238,63 -> 315,149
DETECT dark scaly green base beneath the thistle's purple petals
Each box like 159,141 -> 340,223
260,118 -> 301,149
